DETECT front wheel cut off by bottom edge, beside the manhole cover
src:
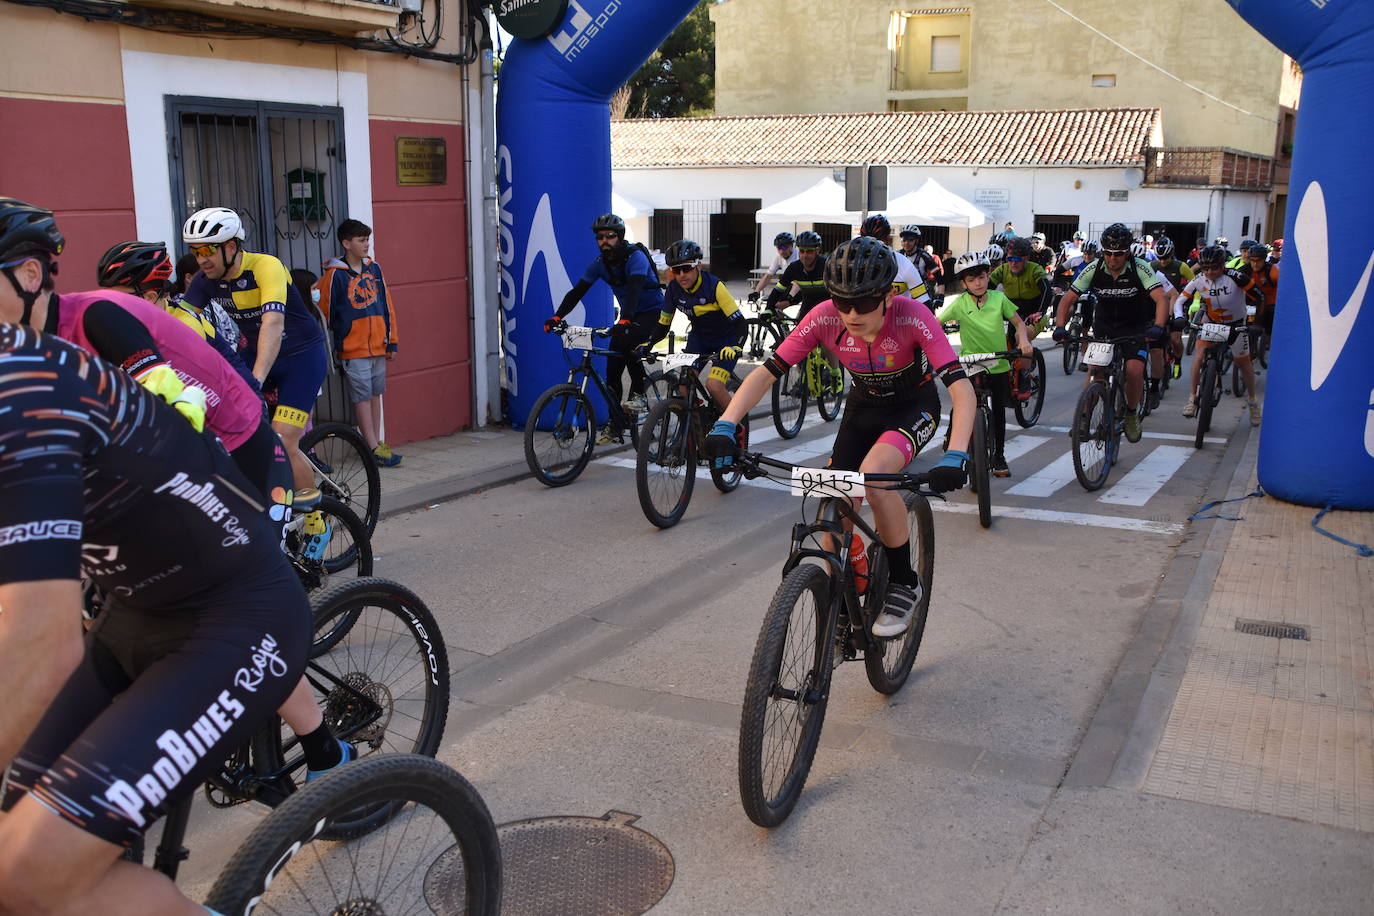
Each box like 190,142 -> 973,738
205,754 -> 502,916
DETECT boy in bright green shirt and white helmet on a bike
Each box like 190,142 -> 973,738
938,251 -> 1039,477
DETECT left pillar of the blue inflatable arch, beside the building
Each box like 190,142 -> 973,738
496,0 -> 697,426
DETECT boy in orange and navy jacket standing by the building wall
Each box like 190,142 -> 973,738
320,220 -> 403,467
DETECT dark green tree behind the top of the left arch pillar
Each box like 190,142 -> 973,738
610,0 -> 716,118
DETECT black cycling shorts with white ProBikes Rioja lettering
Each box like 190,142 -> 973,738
0,563 -> 312,846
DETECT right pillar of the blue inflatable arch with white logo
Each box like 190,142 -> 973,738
1227,0 -> 1374,509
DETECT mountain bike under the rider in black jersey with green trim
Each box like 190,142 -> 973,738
1069,336 -> 1146,492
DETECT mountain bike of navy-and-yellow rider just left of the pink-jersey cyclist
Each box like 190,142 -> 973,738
635,353 -> 749,527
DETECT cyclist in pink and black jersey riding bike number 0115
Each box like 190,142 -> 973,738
705,236 -> 977,639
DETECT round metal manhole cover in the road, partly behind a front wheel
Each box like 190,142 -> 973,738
425,812 -> 675,916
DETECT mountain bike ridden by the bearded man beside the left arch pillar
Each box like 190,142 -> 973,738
525,324 -> 654,486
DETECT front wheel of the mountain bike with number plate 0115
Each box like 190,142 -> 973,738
739,563 -> 834,827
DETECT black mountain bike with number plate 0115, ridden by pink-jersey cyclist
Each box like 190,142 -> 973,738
736,452 -> 934,827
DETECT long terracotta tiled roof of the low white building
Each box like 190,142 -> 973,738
610,108 -> 1160,169
